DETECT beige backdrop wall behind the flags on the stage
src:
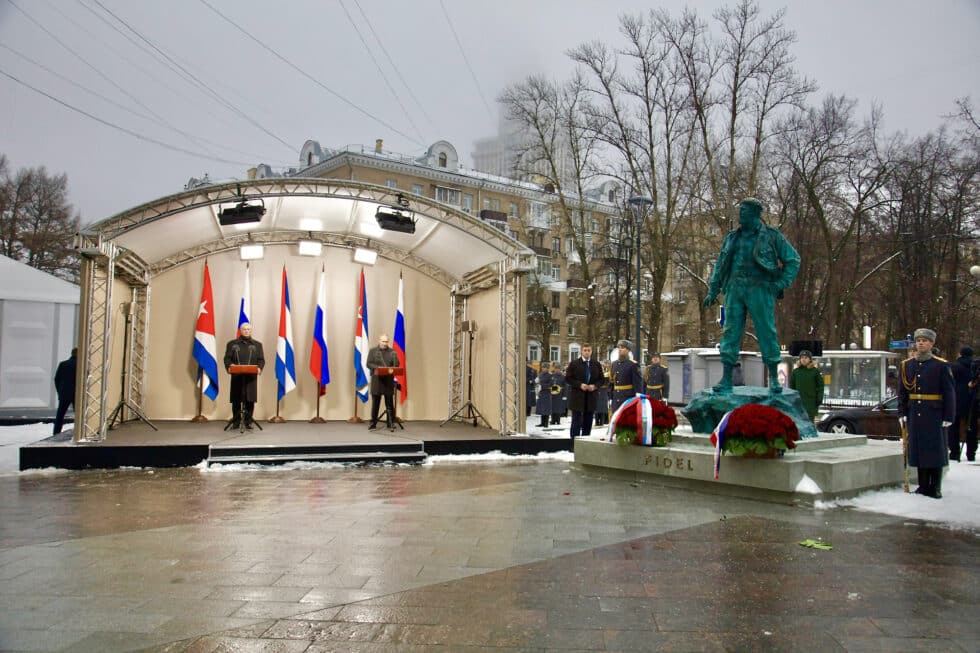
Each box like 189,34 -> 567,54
145,245 -> 452,428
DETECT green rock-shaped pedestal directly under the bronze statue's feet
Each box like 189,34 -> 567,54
681,385 -> 817,440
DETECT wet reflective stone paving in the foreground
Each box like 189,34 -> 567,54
0,462 -> 980,653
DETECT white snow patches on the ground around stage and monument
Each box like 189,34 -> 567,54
0,422 -> 980,529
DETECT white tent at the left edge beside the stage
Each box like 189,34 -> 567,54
0,256 -> 79,419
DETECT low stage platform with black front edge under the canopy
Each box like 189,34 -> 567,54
20,420 -> 571,470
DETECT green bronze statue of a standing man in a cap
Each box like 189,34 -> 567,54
704,198 -> 800,394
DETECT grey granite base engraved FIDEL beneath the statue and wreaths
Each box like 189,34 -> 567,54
575,429 -> 903,504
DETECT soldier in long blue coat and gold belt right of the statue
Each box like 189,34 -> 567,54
898,329 -> 956,499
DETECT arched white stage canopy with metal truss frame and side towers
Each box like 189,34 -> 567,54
75,178 -> 534,441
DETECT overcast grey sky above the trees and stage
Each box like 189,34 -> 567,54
0,0 -> 980,222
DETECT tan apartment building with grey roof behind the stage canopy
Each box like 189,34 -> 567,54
250,140 -> 686,364
